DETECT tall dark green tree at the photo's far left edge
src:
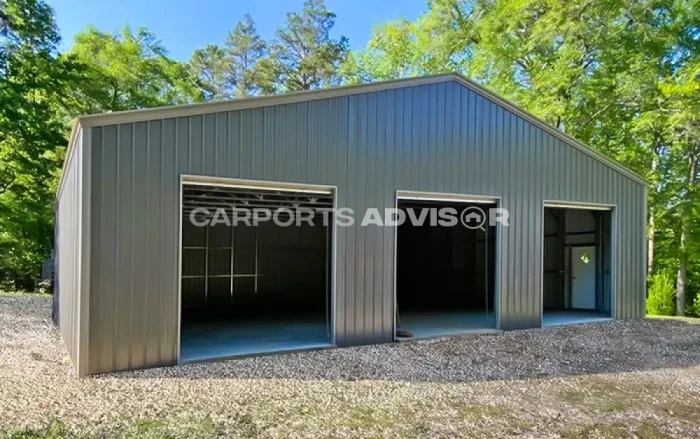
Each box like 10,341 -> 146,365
0,0 -> 75,289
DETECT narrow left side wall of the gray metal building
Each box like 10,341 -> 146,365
55,127 -> 83,371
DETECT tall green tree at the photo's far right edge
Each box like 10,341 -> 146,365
616,1 -> 700,315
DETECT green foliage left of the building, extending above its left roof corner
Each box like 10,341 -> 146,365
0,0 -> 201,291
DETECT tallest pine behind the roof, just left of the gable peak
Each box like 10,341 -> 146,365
262,0 -> 348,91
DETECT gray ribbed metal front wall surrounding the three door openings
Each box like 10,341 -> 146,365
89,81 -> 645,372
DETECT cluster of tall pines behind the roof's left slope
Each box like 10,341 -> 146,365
190,0 -> 348,99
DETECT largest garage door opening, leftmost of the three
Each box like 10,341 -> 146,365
180,184 -> 333,362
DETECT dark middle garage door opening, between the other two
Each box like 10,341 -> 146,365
396,199 -> 496,339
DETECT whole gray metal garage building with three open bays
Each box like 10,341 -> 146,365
56,74 -> 646,375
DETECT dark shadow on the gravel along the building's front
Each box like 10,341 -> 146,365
112,319 -> 700,382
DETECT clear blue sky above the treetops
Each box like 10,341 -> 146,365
48,0 -> 427,61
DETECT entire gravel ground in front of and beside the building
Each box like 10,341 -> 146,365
0,294 -> 700,438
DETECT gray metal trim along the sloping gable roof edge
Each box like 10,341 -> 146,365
69,73 -> 648,185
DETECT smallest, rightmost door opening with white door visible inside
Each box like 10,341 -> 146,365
542,207 -> 612,326
